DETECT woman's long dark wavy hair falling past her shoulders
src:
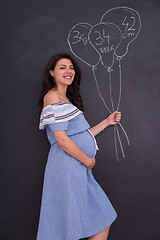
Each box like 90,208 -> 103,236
38,52 -> 84,116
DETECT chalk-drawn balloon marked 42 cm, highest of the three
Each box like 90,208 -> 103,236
101,7 -> 141,57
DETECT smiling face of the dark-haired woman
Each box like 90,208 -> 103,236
50,58 -> 75,86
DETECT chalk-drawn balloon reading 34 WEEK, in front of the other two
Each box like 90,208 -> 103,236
88,22 -> 122,70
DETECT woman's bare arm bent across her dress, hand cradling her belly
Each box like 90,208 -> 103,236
54,130 -> 95,170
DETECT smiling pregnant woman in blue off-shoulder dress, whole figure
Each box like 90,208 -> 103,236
37,53 -> 121,240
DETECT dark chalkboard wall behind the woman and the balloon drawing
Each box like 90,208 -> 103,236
0,0 -> 160,240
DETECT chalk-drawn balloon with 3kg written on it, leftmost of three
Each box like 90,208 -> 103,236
67,23 -> 100,67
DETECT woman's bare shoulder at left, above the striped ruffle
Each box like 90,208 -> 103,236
43,90 -> 60,107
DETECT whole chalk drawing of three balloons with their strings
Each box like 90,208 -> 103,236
67,7 -> 141,162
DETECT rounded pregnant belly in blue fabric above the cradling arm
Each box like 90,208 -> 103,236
69,129 -> 98,157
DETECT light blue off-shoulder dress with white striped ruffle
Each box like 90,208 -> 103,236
37,102 -> 117,240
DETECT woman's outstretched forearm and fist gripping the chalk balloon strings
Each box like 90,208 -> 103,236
89,111 -> 121,137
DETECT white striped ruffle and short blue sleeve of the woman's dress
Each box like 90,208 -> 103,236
39,103 -> 81,132
